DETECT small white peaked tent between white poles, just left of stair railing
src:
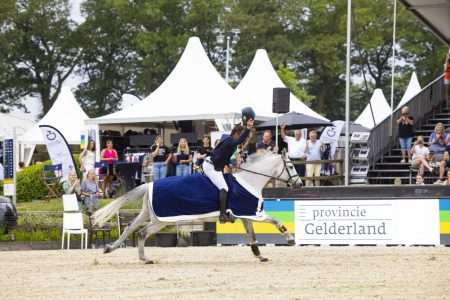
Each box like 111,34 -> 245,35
354,89 -> 391,129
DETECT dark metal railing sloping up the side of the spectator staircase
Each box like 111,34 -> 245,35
368,75 -> 445,167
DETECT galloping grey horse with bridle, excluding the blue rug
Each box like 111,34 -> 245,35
91,151 -> 301,264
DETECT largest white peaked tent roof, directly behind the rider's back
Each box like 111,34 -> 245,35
88,37 -> 243,124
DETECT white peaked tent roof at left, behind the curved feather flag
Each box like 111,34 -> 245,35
19,87 -> 89,145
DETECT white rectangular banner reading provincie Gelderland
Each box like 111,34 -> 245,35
295,199 -> 440,245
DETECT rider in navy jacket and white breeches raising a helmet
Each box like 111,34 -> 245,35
203,107 -> 255,223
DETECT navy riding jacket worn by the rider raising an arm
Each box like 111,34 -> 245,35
211,128 -> 250,171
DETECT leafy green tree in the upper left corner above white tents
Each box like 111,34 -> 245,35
0,0 -> 81,113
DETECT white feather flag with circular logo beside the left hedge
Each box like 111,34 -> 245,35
39,125 -> 76,180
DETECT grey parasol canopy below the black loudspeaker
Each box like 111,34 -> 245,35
256,112 -> 333,129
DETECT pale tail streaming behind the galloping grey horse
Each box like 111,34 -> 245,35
91,184 -> 148,226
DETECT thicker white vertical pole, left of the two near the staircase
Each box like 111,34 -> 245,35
344,0 -> 352,186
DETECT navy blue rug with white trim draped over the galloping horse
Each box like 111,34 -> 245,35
151,174 -> 262,222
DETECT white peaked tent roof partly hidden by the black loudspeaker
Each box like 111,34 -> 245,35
235,49 -> 328,121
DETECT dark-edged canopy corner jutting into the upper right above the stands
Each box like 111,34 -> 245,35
400,0 -> 450,46
